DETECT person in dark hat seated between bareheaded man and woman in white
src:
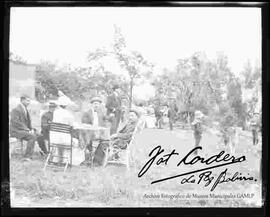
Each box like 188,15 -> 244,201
37,102 -> 57,154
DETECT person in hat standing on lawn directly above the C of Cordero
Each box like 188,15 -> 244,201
191,111 -> 204,154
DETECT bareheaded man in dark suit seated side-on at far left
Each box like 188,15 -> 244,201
10,94 -> 37,161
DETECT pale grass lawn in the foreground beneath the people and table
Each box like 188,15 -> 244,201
10,129 -> 261,207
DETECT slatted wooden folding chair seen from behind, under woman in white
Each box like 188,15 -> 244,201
44,122 -> 72,172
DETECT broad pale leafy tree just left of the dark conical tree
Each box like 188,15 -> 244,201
154,52 -> 219,113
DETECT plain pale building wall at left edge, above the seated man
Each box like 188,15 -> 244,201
9,61 -> 36,99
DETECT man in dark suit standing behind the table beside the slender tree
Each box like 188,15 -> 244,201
106,85 -> 121,135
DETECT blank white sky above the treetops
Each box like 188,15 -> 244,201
10,7 -> 261,99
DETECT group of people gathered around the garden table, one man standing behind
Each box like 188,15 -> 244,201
10,85 -> 140,164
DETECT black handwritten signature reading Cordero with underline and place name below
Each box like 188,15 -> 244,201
138,145 -> 257,191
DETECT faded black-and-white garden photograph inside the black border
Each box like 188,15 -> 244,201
5,6 -> 265,208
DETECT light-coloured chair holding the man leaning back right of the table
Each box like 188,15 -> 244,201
104,120 -> 146,169
